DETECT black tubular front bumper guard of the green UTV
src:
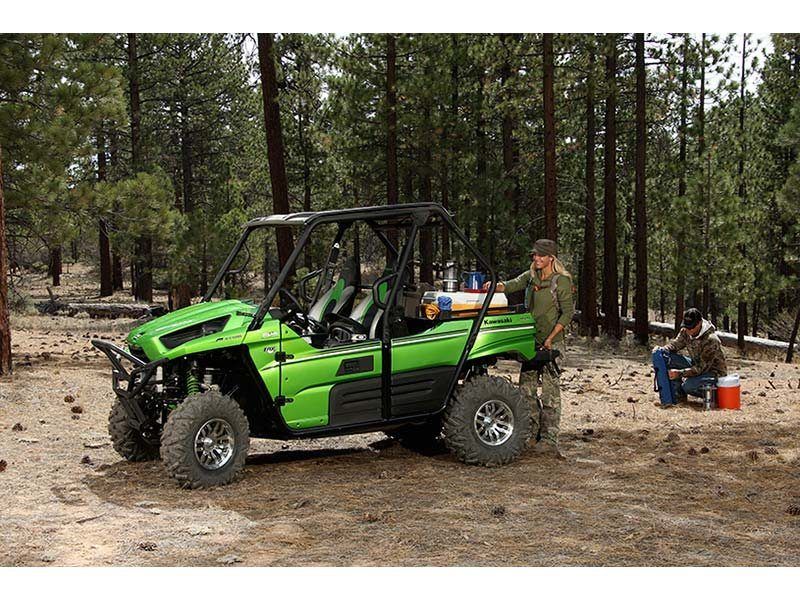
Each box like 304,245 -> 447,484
92,340 -> 167,429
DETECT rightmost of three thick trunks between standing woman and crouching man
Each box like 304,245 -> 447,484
633,33 -> 649,344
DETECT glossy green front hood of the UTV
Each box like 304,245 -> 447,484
126,300 -> 257,361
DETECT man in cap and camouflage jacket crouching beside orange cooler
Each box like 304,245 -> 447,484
653,308 -> 728,408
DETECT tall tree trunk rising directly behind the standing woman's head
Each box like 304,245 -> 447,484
542,33 -> 558,241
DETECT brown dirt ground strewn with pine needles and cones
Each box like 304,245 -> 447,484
0,268 -> 800,566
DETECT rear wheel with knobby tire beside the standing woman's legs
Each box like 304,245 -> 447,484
443,375 -> 531,467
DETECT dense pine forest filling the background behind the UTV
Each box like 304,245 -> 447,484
0,33 -> 800,370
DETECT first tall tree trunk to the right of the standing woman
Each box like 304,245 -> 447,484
581,40 -> 599,337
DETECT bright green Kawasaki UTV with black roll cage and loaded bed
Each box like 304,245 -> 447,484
92,203 -> 553,488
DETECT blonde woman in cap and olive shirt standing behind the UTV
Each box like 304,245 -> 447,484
484,239 -> 575,459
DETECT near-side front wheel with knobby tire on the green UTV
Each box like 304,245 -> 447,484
161,391 -> 250,489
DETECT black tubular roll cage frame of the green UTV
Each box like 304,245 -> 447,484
203,202 -> 497,419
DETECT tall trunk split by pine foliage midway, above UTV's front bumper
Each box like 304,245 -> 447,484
128,33 -> 153,302
